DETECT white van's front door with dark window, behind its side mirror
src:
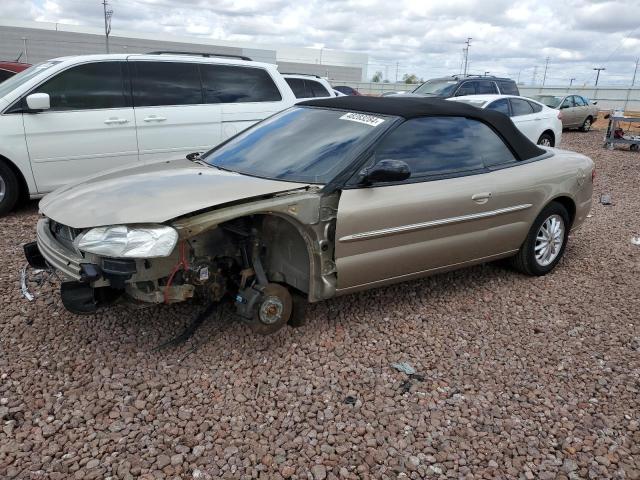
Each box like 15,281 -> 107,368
23,61 -> 138,193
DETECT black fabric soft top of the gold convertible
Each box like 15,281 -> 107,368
298,96 -> 546,160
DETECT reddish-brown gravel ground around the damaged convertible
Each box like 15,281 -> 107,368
0,132 -> 640,480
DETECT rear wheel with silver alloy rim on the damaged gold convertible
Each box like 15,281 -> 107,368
511,202 -> 571,276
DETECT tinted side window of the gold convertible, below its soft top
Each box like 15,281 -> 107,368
374,117 -> 515,179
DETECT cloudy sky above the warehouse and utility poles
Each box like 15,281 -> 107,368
0,0 -> 640,85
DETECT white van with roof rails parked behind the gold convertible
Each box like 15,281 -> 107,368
0,52 -> 296,215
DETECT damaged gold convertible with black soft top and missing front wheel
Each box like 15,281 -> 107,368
25,97 -> 594,333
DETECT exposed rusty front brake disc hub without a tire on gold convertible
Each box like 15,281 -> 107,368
249,283 -> 293,335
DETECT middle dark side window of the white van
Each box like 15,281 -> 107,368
131,62 -> 202,107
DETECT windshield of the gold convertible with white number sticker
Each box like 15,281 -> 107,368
202,107 -> 395,184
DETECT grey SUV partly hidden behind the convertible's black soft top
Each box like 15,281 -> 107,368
392,75 -> 520,98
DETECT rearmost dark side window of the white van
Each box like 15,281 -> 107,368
200,64 -> 282,103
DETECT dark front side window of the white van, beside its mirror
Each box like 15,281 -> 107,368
31,62 -> 131,112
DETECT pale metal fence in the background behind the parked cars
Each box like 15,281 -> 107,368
336,82 -> 640,112
